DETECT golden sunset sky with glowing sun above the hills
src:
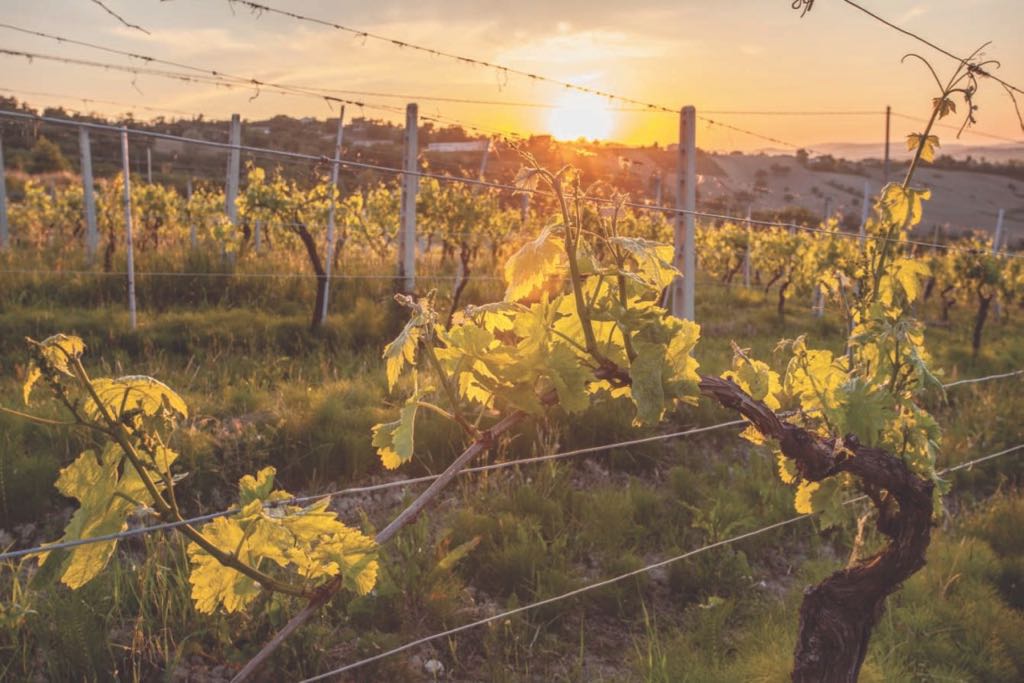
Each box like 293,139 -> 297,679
0,0 -> 1024,151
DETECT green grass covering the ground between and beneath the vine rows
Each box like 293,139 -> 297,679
0,262 -> 1024,681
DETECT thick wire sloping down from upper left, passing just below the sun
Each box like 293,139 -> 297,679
0,110 -> 1024,258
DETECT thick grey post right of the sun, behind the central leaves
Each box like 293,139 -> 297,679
671,105 -> 697,321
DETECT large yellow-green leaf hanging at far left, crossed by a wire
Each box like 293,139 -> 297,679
39,444 -> 177,589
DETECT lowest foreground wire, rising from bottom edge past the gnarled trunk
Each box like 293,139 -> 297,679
300,443 -> 1024,683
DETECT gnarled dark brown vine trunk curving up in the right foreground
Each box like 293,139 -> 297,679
700,377 -> 933,683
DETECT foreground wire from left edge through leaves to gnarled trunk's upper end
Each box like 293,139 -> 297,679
0,370 -> 1024,561
